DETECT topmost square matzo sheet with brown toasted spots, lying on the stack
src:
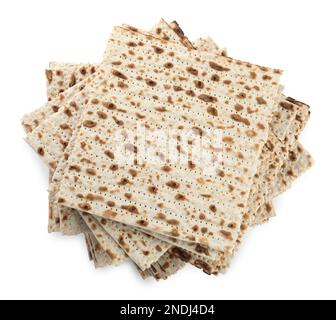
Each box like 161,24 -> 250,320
54,28 -> 280,251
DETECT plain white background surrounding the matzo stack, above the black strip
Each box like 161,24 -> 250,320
0,0 -> 336,299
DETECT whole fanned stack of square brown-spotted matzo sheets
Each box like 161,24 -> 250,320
22,20 -> 312,279
